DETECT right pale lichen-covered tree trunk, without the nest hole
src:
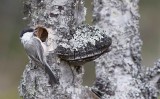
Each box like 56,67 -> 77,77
93,0 -> 159,99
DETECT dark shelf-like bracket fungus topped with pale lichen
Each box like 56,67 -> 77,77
55,24 -> 112,66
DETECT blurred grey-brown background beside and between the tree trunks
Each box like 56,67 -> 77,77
0,0 -> 160,99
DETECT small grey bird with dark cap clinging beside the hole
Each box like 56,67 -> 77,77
20,28 -> 59,85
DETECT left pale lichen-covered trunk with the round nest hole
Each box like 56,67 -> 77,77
19,0 -> 99,99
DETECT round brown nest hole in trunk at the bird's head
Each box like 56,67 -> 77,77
36,26 -> 48,42
